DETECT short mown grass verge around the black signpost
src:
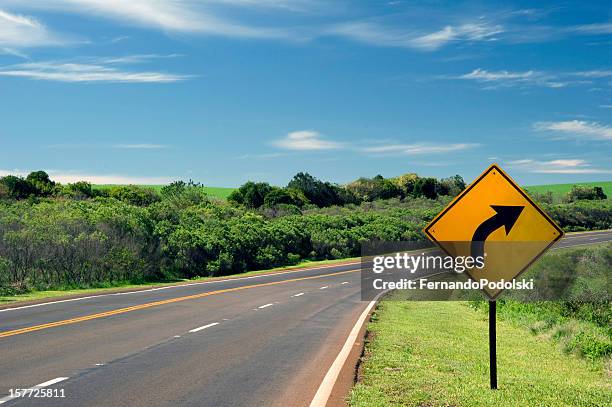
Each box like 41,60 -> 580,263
349,294 -> 612,407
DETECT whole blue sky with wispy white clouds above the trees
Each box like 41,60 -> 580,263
0,0 -> 612,186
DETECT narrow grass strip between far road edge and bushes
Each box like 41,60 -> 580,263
0,257 -> 360,305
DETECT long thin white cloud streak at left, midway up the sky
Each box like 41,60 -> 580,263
0,61 -> 190,83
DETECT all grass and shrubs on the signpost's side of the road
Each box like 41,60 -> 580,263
349,244 -> 612,406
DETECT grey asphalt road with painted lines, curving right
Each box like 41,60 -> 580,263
0,231 -> 612,406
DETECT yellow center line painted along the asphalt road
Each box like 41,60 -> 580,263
0,269 -> 360,338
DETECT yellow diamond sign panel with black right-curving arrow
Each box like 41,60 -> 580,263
423,164 -> 563,299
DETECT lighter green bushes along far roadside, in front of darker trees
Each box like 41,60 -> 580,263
0,183 -> 444,294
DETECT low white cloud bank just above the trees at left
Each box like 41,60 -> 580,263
0,169 -> 180,185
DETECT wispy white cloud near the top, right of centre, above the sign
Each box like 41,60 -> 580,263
327,21 -> 503,51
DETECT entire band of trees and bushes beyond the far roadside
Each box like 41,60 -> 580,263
0,171 -> 612,294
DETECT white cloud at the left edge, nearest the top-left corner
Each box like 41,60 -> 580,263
0,10 -> 67,47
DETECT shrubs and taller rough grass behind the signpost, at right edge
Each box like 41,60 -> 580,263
471,243 -> 612,368
